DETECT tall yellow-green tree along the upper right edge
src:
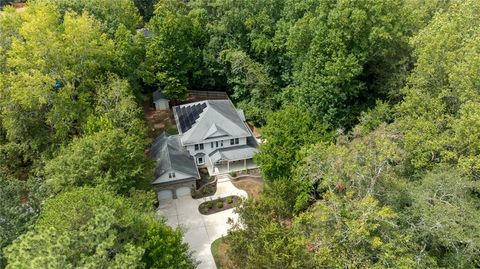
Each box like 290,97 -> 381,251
396,1 -> 480,172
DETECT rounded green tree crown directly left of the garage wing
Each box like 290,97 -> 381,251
45,129 -> 148,193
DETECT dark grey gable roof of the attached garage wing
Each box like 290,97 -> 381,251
150,133 -> 200,184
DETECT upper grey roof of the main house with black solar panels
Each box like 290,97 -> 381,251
173,100 -> 250,145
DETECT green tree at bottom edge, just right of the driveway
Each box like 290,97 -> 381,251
226,198 -> 315,268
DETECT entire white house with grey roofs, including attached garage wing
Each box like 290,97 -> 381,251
150,100 -> 258,200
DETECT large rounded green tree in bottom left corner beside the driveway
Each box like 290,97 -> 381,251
5,188 -> 193,268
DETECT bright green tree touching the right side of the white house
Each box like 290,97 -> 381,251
255,105 -> 331,180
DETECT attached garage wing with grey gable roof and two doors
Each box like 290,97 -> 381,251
150,133 -> 200,199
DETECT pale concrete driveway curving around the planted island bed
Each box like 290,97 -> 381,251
157,176 -> 247,269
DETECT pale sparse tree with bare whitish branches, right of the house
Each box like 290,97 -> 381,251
295,125 -> 405,206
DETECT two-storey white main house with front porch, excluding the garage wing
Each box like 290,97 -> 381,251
173,100 -> 258,175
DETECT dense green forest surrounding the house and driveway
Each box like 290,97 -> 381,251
0,0 -> 480,268
